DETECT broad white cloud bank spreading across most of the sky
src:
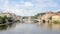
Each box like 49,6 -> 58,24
0,0 -> 60,16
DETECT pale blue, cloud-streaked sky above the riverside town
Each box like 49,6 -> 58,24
0,0 -> 60,16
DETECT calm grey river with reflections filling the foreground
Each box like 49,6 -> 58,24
0,22 -> 60,34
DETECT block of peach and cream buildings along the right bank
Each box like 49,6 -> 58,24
40,11 -> 60,20
